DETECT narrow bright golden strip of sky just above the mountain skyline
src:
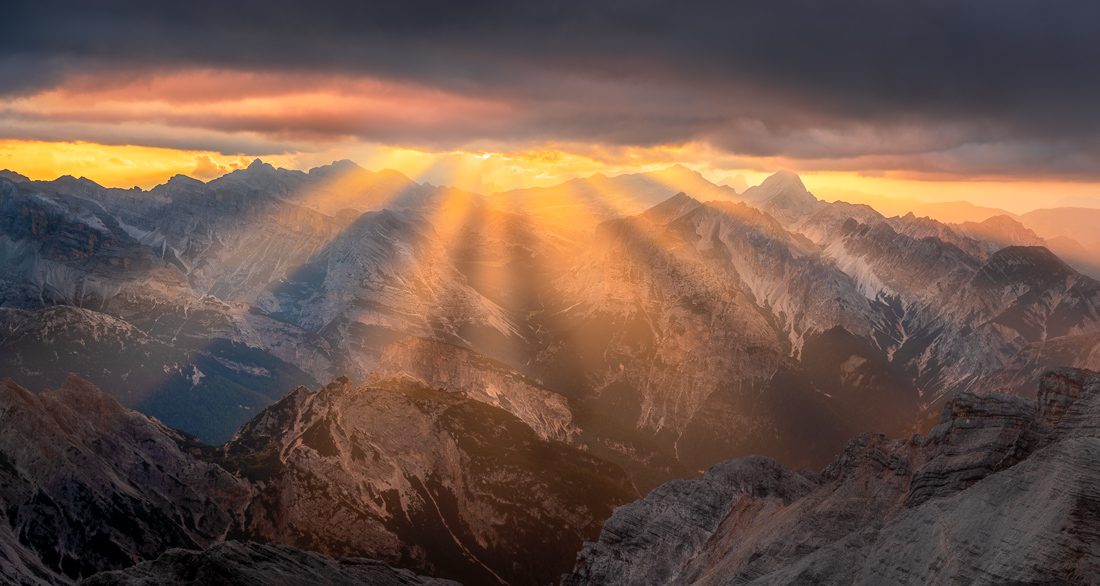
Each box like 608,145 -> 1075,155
0,140 -> 1100,213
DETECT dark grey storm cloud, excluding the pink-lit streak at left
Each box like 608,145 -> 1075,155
0,0 -> 1100,175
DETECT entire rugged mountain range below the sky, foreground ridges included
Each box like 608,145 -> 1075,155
0,161 -> 1100,584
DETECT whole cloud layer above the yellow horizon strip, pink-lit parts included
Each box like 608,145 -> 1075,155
0,0 -> 1100,179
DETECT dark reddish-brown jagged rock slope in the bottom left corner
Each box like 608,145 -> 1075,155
0,377 -> 250,583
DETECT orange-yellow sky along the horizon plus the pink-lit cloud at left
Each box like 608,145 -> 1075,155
0,69 -> 1100,212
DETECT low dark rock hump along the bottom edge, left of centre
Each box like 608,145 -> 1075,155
81,541 -> 459,586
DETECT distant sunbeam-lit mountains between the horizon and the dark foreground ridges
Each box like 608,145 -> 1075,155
0,161 -> 1100,483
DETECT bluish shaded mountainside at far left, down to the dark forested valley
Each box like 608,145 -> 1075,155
0,174 -> 329,441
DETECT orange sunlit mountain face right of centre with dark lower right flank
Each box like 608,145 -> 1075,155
540,195 -> 916,474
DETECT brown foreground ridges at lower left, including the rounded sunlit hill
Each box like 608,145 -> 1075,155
0,377 -> 638,584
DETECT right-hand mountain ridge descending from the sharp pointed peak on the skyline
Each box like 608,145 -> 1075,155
745,175 -> 1100,403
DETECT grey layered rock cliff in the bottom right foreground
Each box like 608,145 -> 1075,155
565,368 -> 1100,585
